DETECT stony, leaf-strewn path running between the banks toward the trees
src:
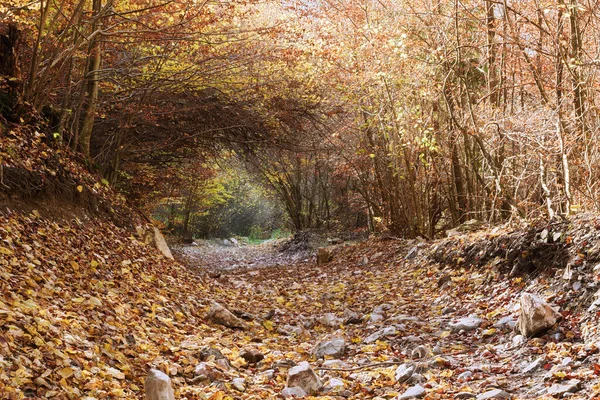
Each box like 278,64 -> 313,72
171,239 -> 596,399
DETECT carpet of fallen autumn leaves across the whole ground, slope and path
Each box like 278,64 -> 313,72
0,206 -> 600,400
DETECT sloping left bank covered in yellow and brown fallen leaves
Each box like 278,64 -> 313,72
0,213 -> 212,398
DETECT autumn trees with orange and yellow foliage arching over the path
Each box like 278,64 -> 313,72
0,0 -> 600,237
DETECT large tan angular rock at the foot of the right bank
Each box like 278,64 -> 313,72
517,293 -> 561,337
